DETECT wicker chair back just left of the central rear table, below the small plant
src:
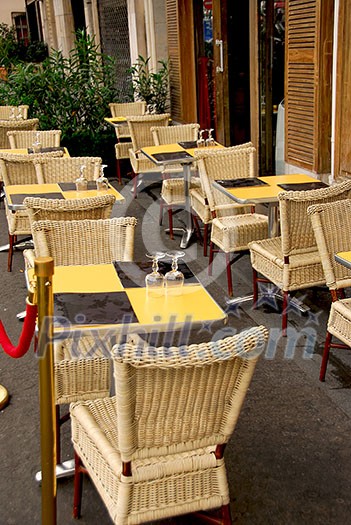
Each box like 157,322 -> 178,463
127,113 -> 170,152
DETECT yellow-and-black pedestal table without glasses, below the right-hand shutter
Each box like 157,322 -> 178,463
213,173 -> 327,236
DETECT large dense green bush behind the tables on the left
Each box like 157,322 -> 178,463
0,31 -> 117,168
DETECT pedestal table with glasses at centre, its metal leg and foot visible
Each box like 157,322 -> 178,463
141,143 -> 223,248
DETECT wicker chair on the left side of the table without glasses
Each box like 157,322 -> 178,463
196,147 -> 268,296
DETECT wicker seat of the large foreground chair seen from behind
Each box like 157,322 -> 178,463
71,398 -> 229,525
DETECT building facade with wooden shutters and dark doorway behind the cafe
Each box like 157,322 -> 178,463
2,0 -> 351,179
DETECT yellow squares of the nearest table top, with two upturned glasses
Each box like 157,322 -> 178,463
27,263 -> 227,332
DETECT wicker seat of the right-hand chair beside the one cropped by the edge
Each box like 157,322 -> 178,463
249,237 -> 325,291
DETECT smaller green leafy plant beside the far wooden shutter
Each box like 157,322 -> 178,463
129,55 -> 169,113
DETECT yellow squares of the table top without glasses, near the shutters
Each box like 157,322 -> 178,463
214,173 -> 324,204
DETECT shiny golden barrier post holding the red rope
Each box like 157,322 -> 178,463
34,257 -> 56,525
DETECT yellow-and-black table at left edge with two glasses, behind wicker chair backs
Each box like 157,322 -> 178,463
4,181 -> 124,211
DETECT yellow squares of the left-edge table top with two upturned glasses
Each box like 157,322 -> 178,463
4,184 -> 124,210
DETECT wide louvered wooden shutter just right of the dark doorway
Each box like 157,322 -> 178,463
285,0 -> 333,173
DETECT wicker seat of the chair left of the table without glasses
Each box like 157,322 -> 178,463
211,213 -> 268,253
